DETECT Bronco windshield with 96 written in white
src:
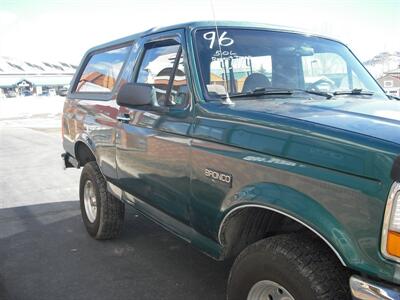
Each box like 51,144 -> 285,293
195,27 -> 387,100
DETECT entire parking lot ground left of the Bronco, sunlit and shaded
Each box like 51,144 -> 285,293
0,120 -> 230,300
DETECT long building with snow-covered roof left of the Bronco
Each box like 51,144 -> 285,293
0,57 -> 77,97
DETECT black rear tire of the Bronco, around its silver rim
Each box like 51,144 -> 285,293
79,161 -> 125,240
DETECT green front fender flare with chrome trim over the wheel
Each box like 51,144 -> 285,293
218,183 -> 357,266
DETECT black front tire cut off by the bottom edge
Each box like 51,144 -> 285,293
227,234 -> 351,300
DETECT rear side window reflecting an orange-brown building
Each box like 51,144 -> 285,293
75,46 -> 130,93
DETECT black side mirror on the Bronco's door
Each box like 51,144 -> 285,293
117,83 -> 155,106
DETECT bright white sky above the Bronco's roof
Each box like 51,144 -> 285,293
0,0 -> 400,64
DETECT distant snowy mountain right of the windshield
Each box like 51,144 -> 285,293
364,51 -> 400,78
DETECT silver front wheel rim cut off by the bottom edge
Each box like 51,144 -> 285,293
247,280 -> 294,300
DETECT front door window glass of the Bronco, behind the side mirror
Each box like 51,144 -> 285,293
136,45 -> 189,106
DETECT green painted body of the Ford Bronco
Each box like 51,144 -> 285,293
63,22 -> 400,298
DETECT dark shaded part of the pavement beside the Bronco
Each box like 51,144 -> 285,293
0,201 -> 229,300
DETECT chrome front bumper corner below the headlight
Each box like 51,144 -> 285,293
350,275 -> 400,300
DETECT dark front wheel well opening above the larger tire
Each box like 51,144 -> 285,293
218,206 -> 345,265
